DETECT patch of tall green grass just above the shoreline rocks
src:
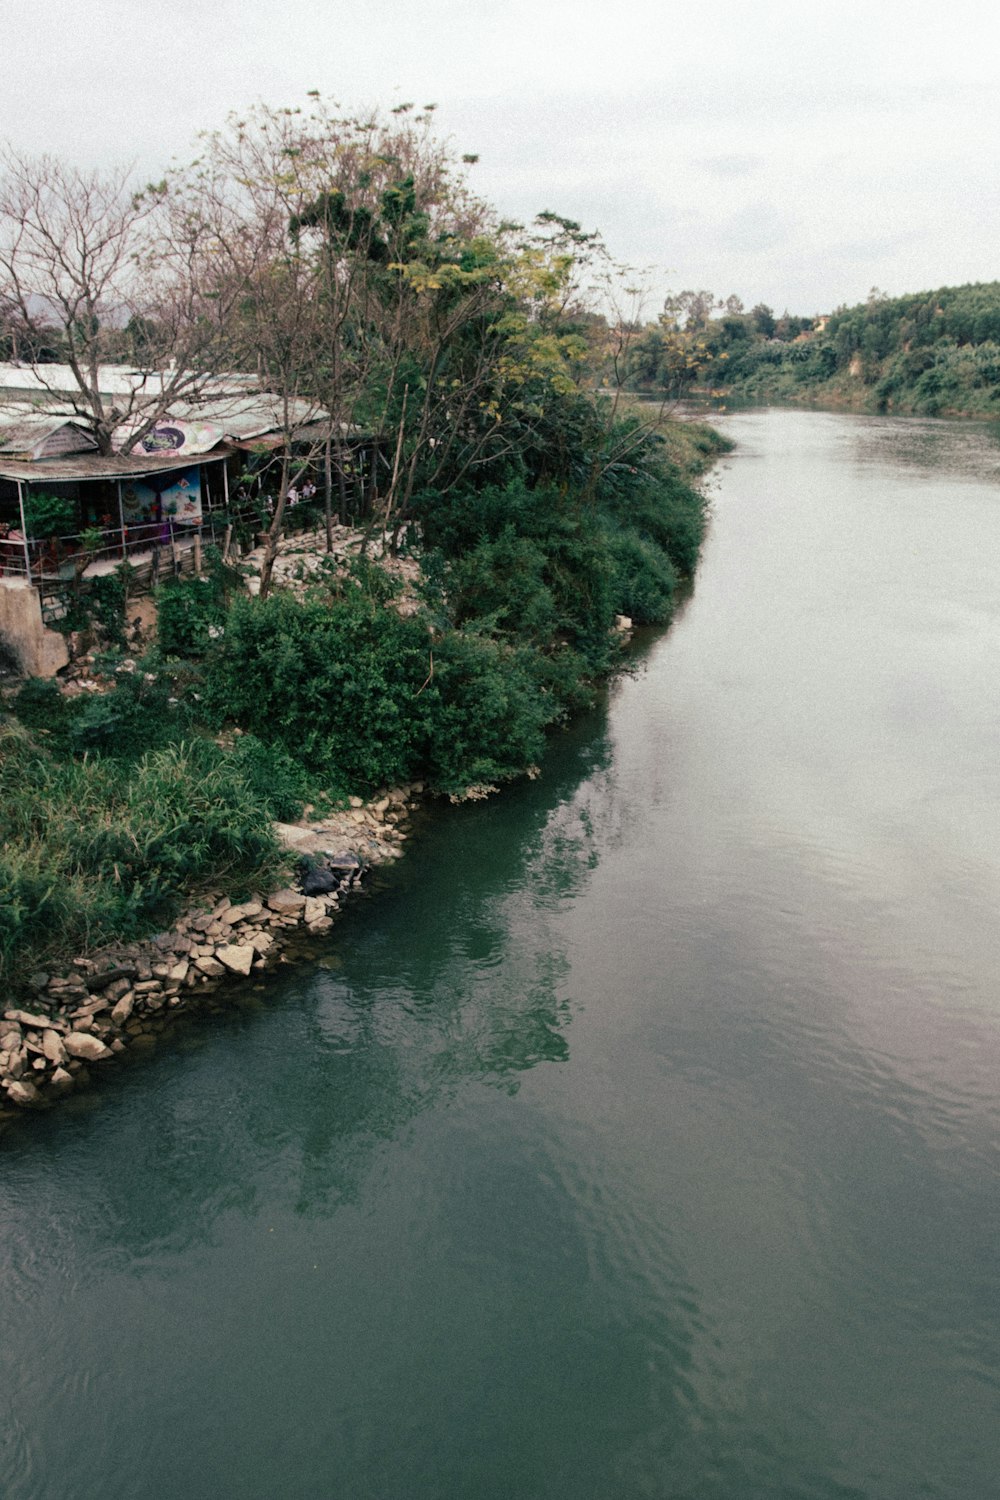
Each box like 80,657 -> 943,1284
0,725 -> 279,978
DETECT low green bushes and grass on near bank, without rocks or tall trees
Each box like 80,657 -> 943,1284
0,423 -> 726,984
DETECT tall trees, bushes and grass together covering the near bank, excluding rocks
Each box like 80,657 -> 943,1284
0,99 -> 723,975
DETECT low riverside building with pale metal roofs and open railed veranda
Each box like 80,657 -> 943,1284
0,365 -> 379,675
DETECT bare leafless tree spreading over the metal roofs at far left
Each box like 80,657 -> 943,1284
0,149 -> 245,453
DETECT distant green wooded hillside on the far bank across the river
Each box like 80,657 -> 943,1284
628,282 -> 1000,416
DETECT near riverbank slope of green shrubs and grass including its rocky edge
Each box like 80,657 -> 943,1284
0,423 -> 727,1107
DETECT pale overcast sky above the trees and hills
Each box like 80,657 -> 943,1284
0,0 -> 1000,315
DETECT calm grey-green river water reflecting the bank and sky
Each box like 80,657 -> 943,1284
0,411 -> 1000,1500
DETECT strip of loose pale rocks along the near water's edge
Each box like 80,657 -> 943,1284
0,783 -> 423,1124
